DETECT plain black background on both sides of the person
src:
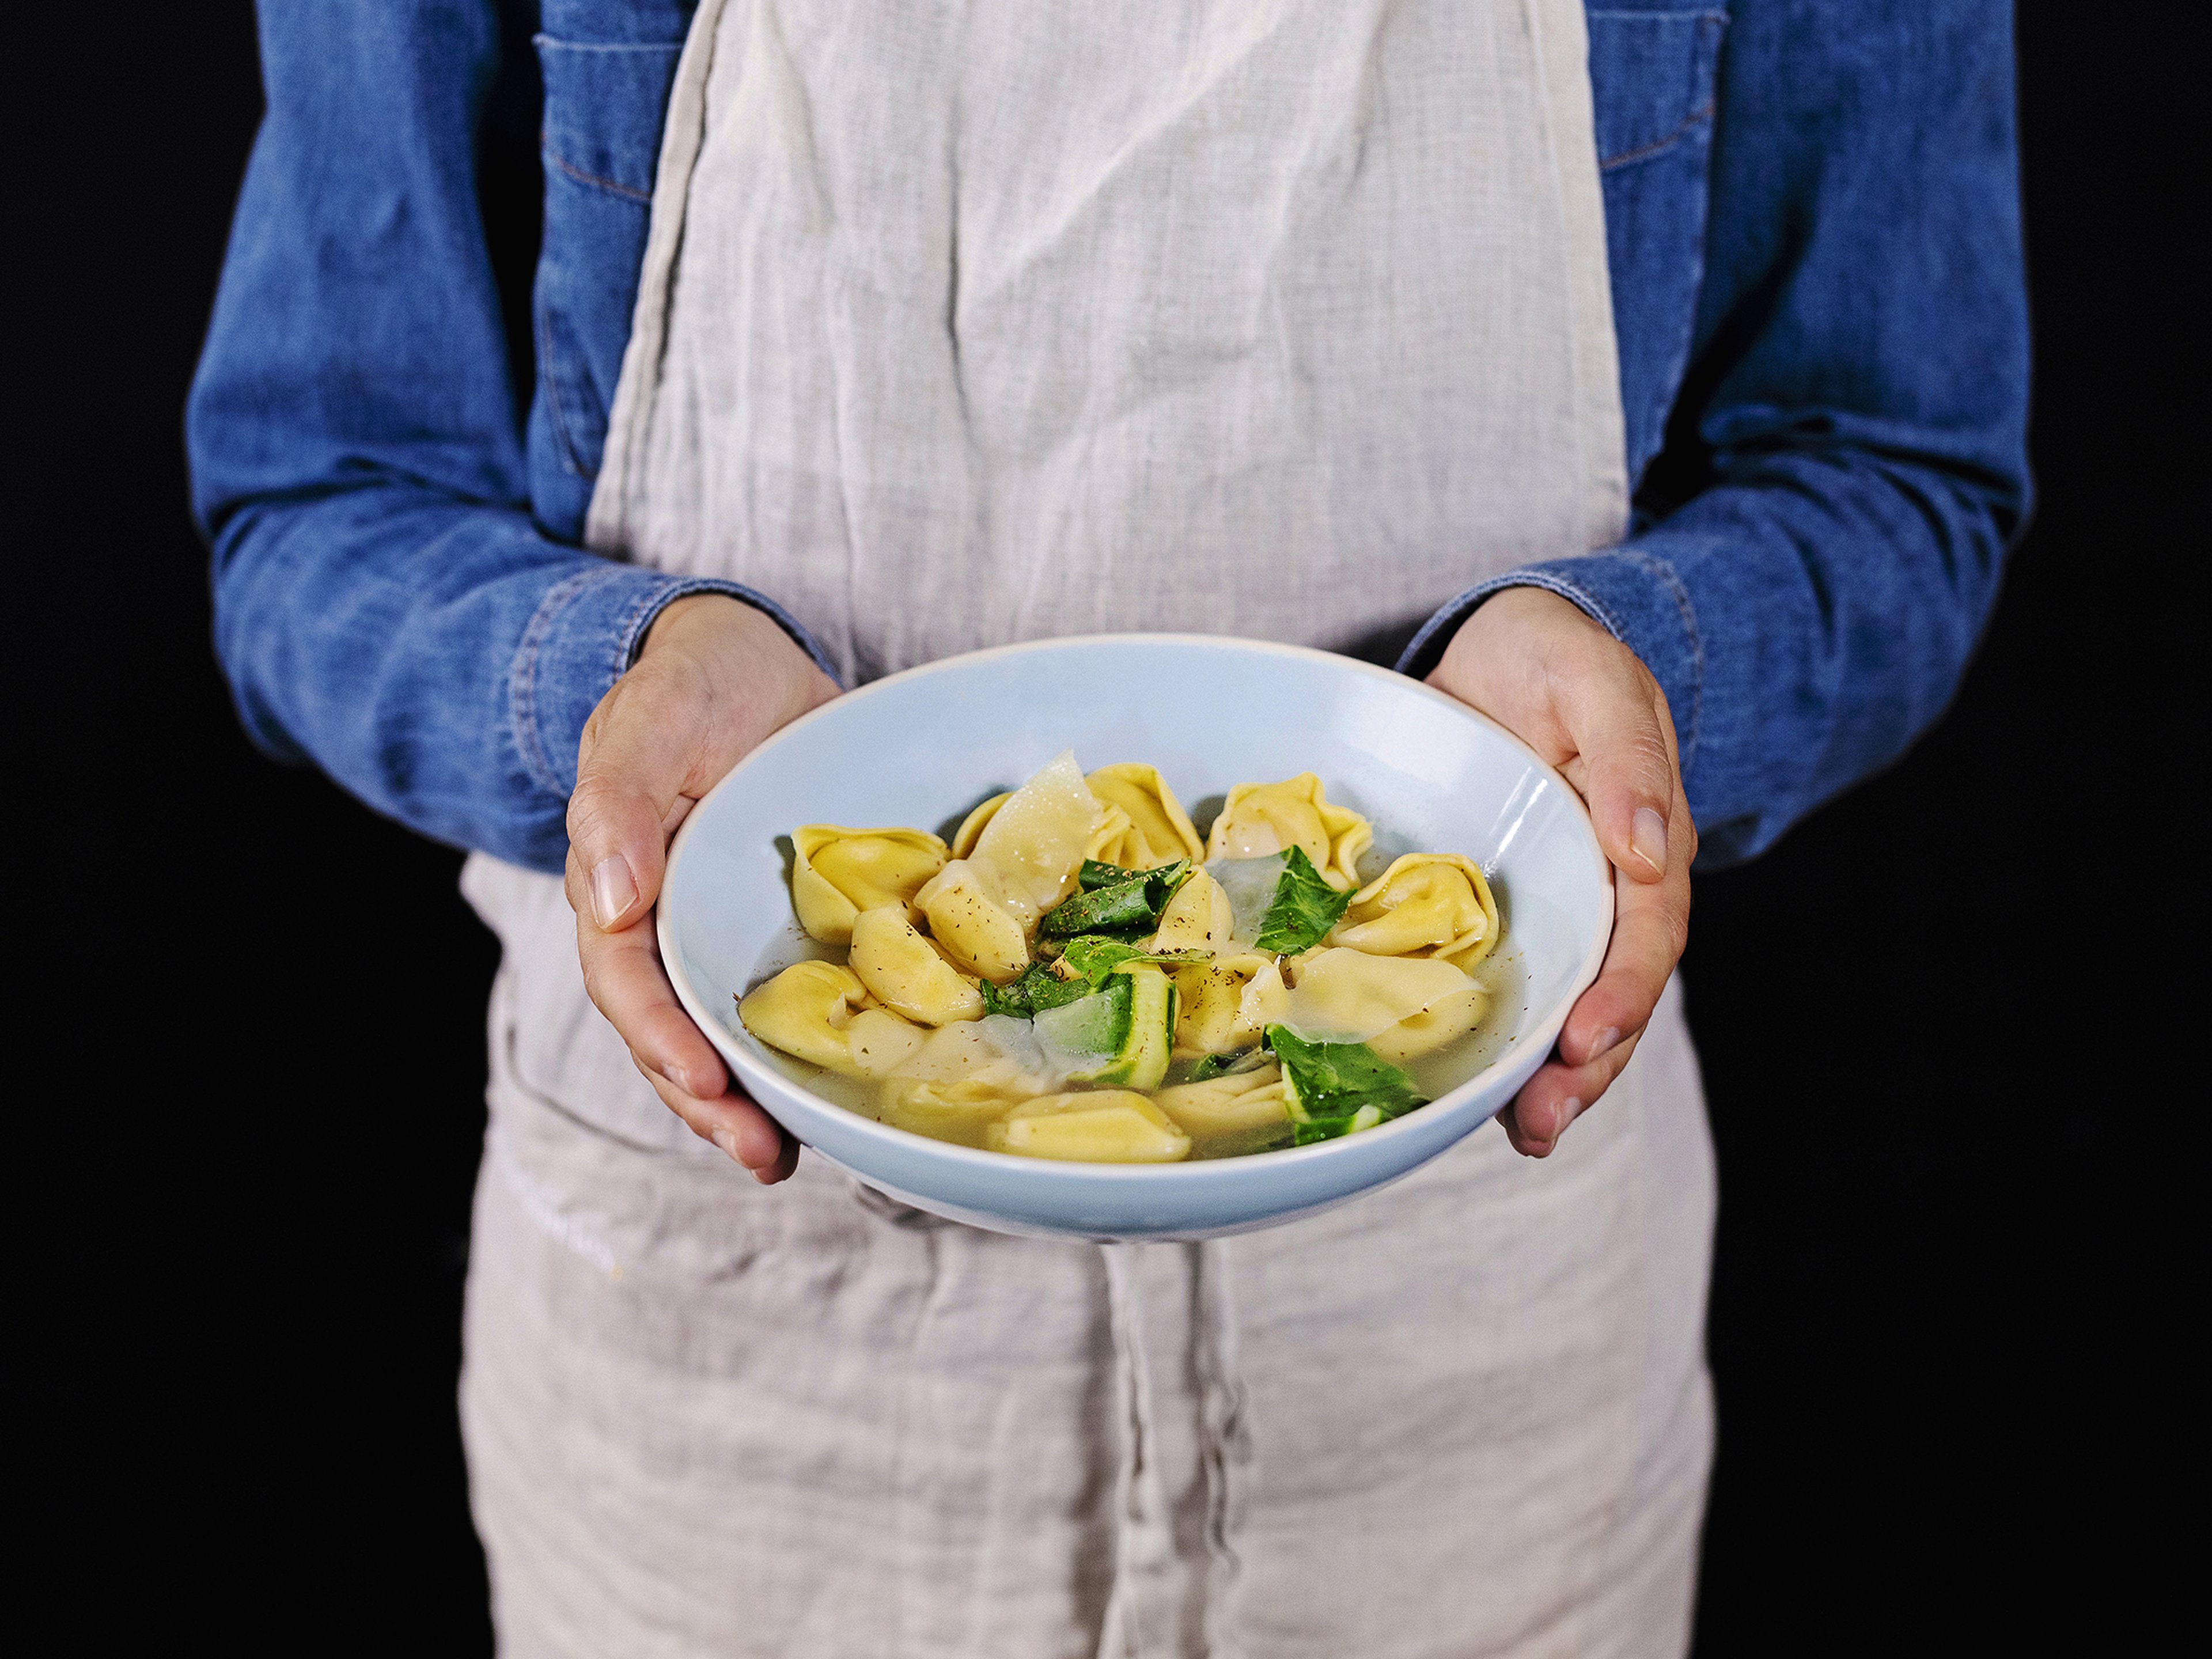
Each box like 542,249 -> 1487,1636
17,0 -> 2205,1659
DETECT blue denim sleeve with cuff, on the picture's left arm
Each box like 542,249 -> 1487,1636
186,0 -> 827,872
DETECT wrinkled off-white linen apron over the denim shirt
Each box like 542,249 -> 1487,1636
463,0 -> 1714,1659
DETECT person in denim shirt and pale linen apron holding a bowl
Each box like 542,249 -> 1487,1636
188,0 -> 2028,1659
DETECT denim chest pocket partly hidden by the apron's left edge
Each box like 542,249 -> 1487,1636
531,35 -> 684,535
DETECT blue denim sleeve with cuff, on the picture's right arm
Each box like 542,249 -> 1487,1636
1400,0 -> 2028,863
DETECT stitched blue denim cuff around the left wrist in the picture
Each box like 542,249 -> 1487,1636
506,562 -> 838,798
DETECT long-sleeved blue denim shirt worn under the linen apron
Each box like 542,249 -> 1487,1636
188,0 -> 2028,869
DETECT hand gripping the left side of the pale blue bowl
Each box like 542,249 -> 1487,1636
569,593 -> 836,1183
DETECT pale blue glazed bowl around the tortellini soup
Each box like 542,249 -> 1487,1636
659,635 -> 1612,1241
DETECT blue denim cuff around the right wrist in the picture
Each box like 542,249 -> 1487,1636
1398,553 -> 1706,772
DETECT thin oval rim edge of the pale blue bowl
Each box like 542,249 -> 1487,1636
653,632 -> 1615,1183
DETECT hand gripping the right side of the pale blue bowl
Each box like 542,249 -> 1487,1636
1429,588 -> 1696,1157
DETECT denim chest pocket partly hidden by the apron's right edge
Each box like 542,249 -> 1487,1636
1588,11 -> 1728,487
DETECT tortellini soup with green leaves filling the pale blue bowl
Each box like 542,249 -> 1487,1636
737,752 -> 1502,1164
